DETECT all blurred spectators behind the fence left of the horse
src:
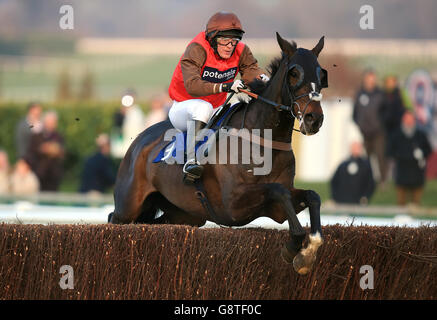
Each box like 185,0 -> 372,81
0,90 -> 168,196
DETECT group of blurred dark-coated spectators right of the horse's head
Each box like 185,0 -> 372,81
330,69 -> 435,205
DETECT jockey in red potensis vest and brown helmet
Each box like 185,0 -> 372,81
169,12 -> 269,179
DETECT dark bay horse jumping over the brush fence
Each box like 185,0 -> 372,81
109,33 -> 327,274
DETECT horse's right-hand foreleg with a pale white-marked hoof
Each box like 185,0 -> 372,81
290,189 -> 323,273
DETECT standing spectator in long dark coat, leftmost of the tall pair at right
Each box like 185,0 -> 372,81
353,70 -> 387,184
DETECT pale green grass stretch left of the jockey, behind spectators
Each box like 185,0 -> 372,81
0,55 -> 179,101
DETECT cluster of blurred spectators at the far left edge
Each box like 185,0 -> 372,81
0,102 -> 65,195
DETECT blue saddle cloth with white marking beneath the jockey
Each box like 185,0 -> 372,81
153,103 -> 239,164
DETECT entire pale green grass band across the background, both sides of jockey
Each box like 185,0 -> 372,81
0,53 -> 437,101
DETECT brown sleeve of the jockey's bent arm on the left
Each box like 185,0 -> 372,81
181,43 -> 220,97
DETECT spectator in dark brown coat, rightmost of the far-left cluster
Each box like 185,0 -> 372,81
27,111 -> 65,191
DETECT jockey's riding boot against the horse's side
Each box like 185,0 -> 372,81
183,120 -> 206,183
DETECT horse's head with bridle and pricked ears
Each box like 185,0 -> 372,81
276,33 -> 328,135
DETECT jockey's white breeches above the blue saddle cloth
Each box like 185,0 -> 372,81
168,99 -> 214,131
